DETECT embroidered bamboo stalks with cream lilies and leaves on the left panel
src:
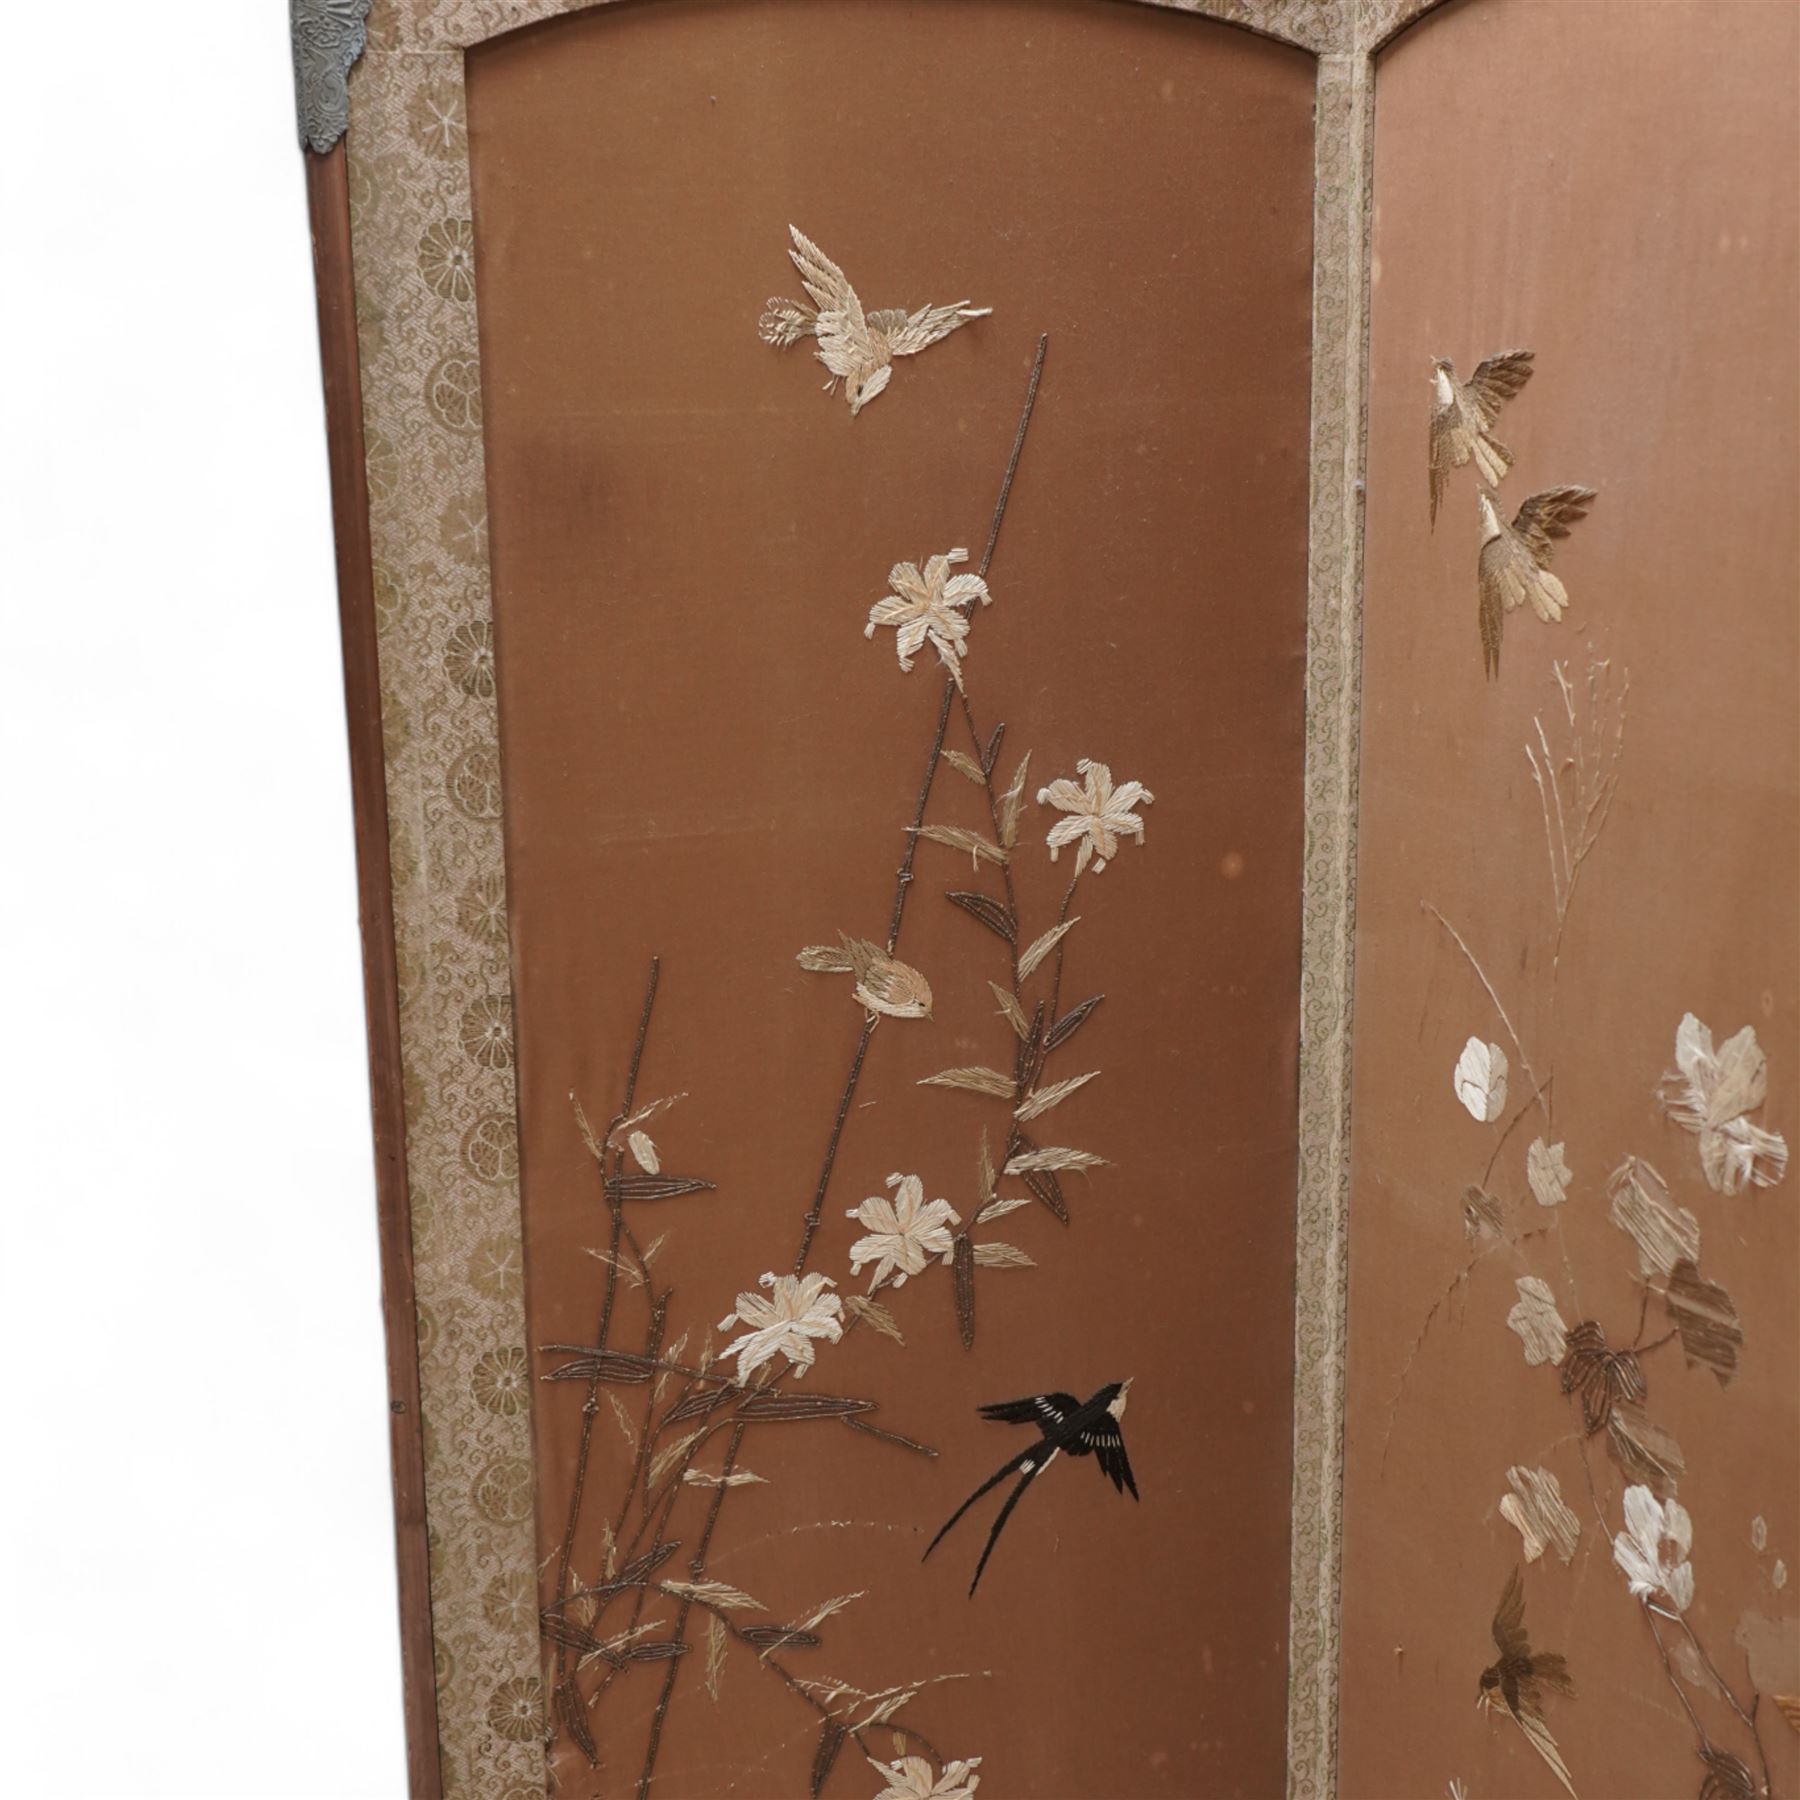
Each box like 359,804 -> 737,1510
540,334 -> 1150,1800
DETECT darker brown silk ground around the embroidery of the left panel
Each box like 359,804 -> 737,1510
468,0 -> 1314,1796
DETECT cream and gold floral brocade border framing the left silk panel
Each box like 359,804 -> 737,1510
347,0 -> 1433,1795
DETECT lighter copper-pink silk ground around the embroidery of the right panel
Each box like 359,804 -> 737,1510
1341,0 -> 1800,1800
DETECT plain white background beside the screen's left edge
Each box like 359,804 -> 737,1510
0,0 -> 405,1796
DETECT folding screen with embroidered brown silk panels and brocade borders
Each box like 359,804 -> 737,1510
293,0 -> 1800,1800
